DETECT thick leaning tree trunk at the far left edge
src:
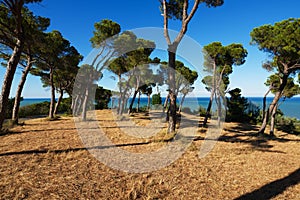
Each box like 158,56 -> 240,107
0,39 -> 23,130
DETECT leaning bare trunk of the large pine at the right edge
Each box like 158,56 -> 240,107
258,74 -> 289,134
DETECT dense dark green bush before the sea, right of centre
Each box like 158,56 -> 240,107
226,88 -> 259,123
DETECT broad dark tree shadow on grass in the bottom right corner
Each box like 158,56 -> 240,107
235,168 -> 300,200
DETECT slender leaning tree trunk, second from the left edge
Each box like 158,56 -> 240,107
12,55 -> 32,124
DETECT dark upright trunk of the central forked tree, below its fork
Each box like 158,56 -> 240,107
168,49 -> 176,133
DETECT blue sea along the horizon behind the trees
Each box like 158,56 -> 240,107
21,97 -> 300,120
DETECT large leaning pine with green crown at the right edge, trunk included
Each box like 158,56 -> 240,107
250,18 -> 300,134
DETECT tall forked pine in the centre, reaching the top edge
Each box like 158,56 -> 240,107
159,0 -> 224,133
